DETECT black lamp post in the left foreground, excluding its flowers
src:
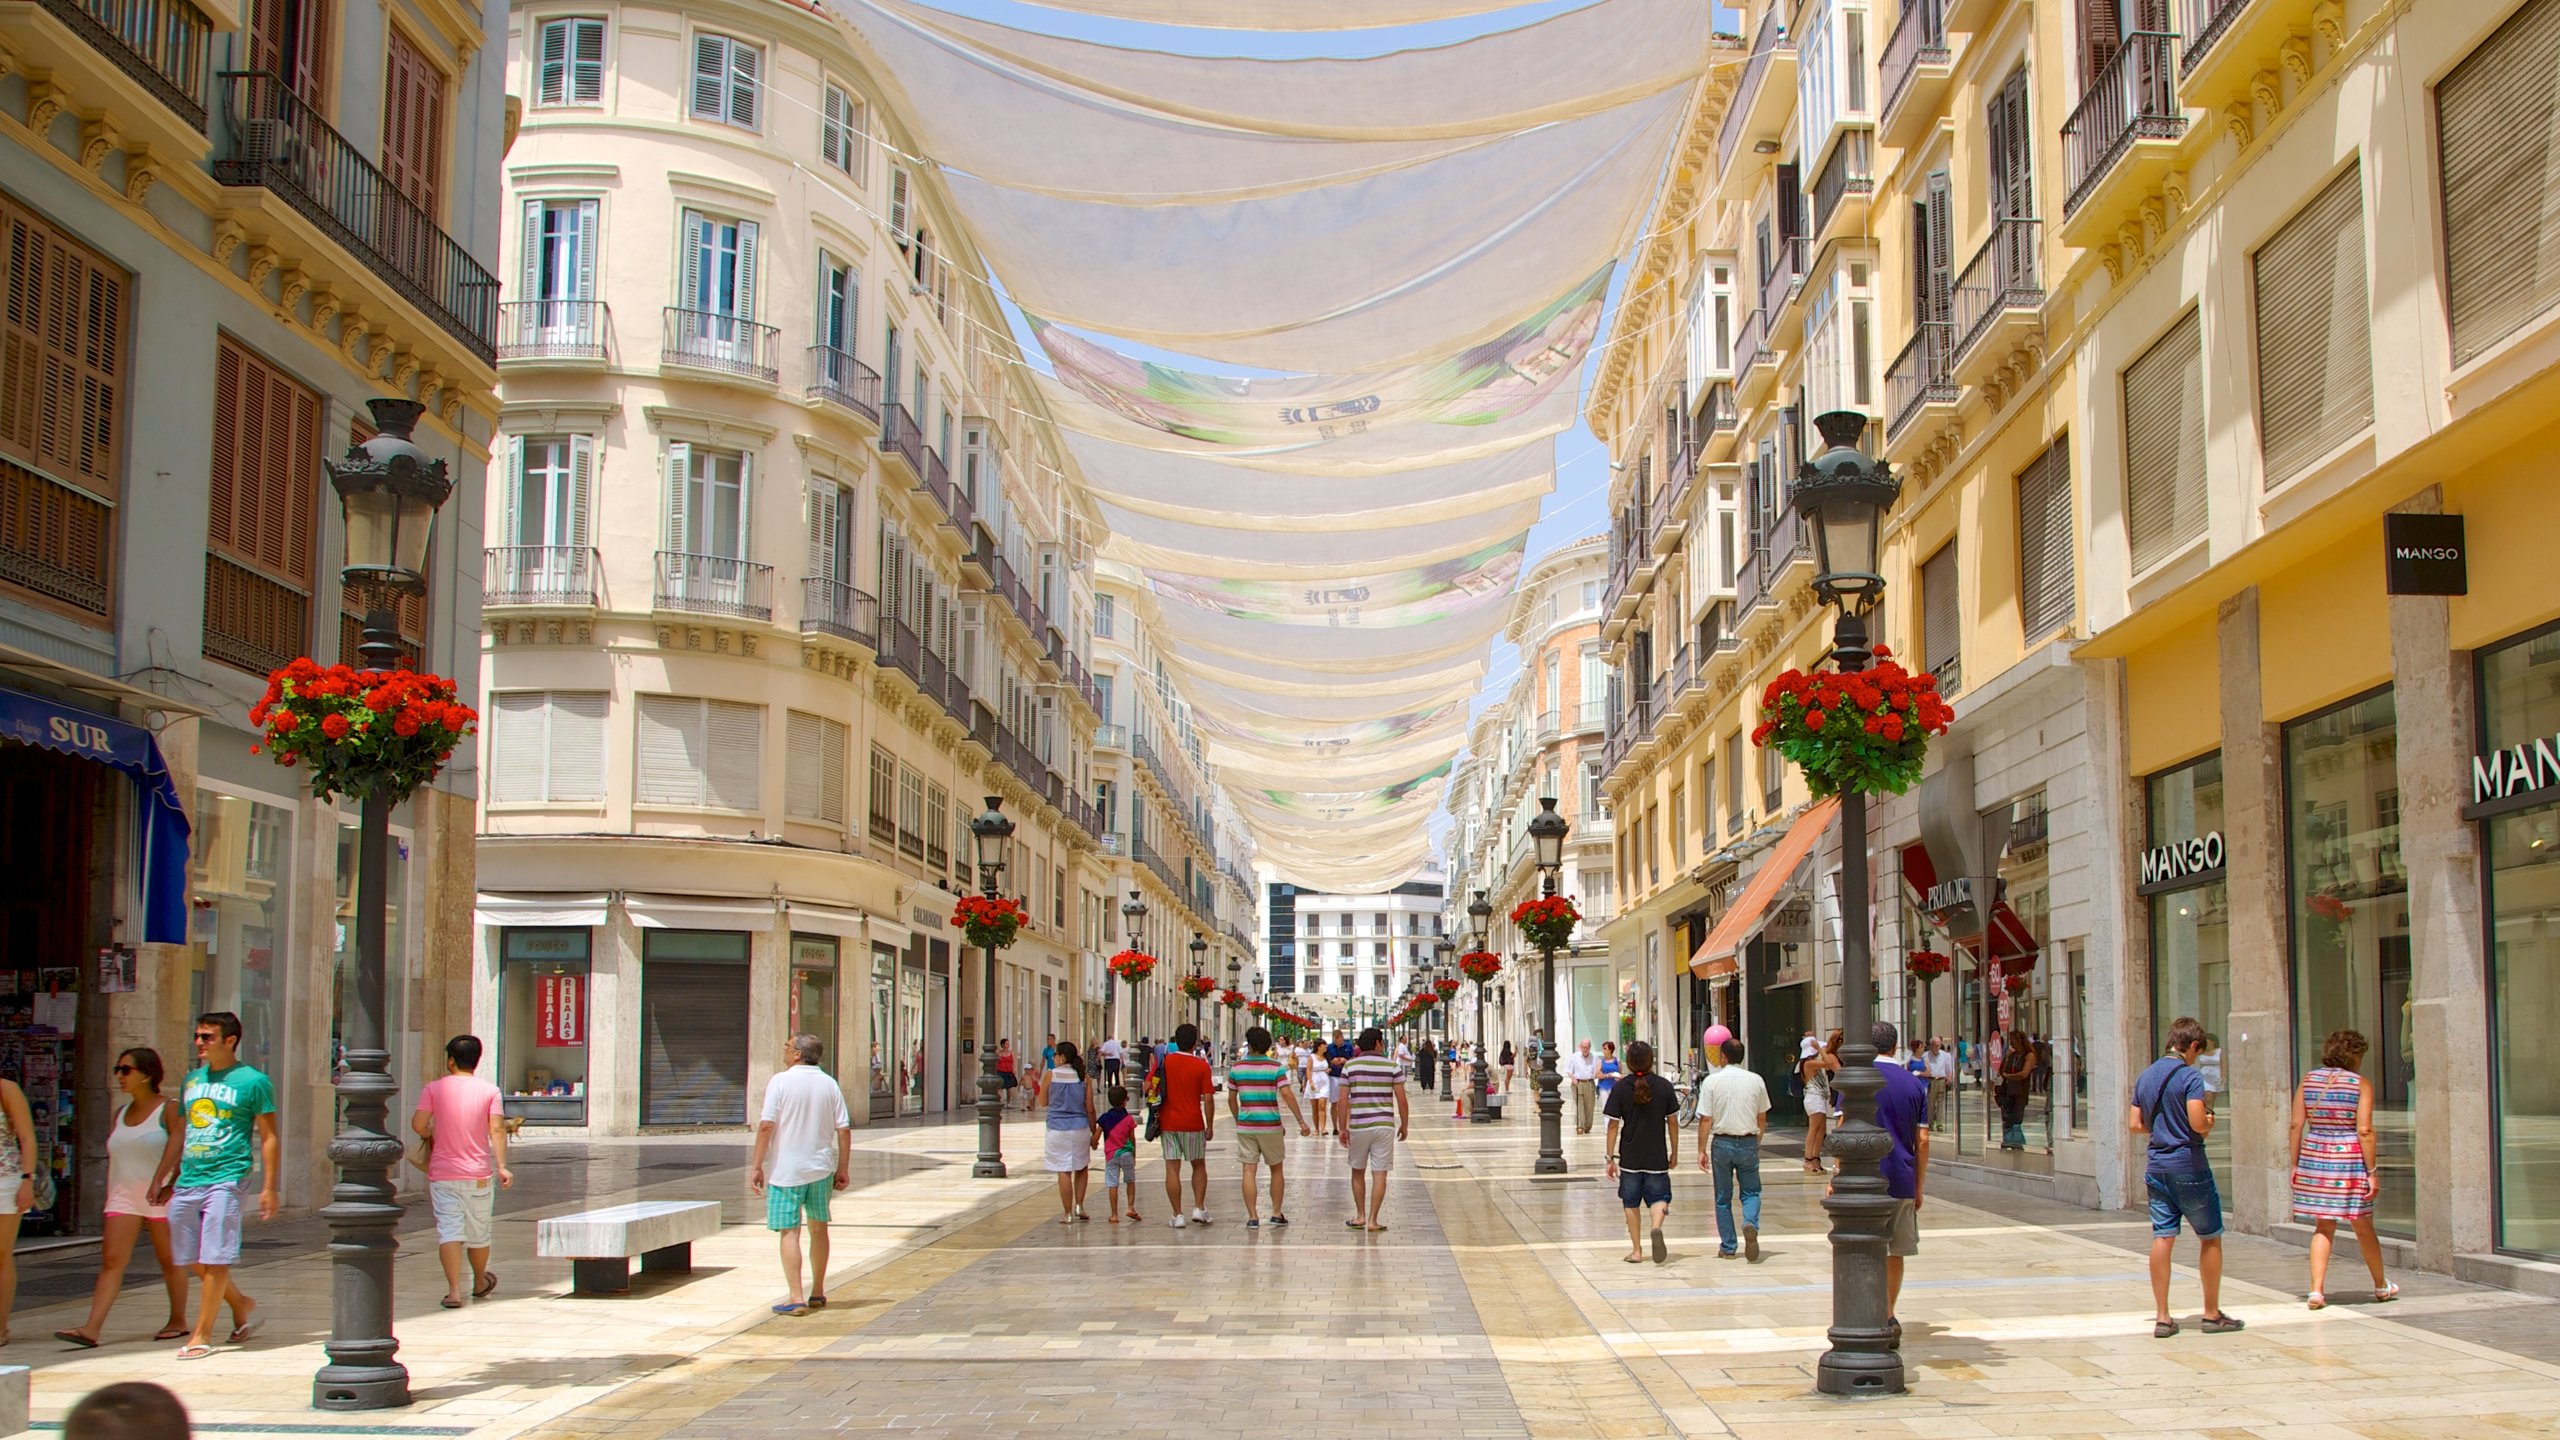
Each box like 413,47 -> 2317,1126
312,400 -> 453,1409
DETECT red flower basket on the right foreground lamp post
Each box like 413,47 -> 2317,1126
1751,646 -> 1956,797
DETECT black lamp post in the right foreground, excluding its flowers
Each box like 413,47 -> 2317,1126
1787,410 -> 1902,1394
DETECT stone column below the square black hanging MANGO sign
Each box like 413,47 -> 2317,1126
2391,487 -> 2496,1271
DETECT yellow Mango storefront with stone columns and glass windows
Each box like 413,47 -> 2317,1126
2079,443 -> 2560,1276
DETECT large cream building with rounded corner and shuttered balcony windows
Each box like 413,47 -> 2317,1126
476,0 -> 1116,1135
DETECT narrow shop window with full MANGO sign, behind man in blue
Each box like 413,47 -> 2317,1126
2135,753 -> 2232,1194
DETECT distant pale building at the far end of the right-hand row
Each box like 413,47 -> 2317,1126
1449,536 -> 1607,1048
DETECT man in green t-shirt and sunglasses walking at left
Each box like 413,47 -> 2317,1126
151,1010 -> 284,1361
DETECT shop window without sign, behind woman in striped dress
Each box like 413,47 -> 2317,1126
2284,689 -> 2419,1235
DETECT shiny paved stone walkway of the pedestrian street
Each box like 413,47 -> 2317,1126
15,1091 -> 2560,1440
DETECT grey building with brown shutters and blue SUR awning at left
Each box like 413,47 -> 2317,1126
0,0 -> 504,1214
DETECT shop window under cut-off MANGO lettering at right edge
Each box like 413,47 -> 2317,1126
2470,625 -> 2560,1258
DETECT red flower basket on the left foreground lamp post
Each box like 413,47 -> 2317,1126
248,656 -> 479,802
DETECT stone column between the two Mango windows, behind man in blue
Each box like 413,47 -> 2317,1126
2211,587 -> 2294,1235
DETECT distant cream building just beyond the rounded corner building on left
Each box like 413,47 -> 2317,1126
1093,561 -> 1262,1040
